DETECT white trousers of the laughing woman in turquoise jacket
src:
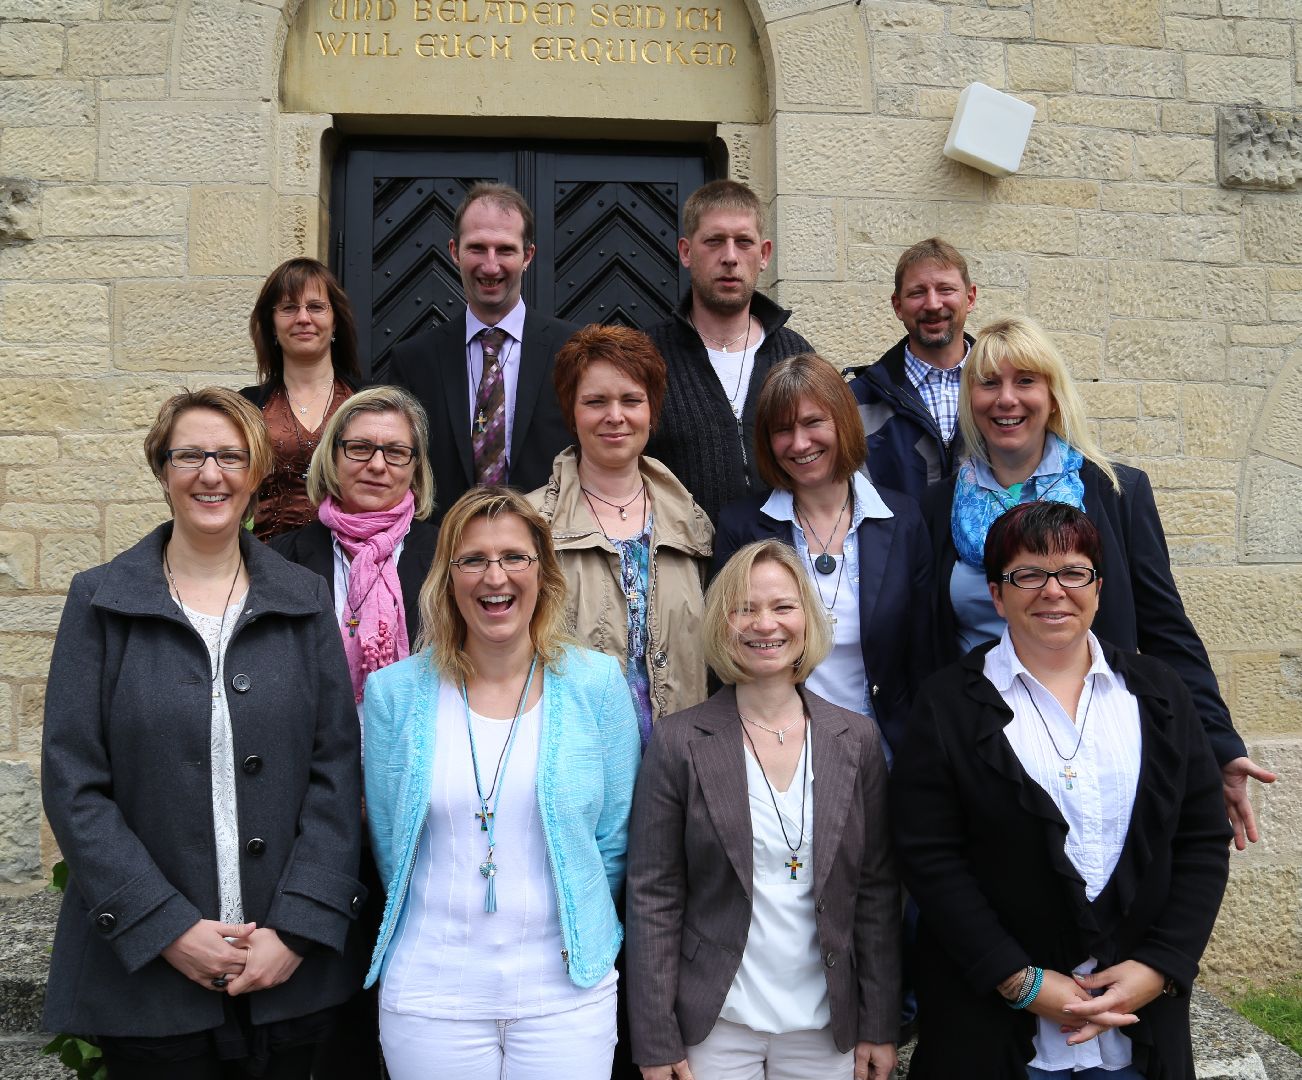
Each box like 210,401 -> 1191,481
380,986 -> 616,1080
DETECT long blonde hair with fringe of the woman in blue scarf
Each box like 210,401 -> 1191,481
958,315 -> 1121,492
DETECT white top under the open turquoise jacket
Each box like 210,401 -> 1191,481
380,680 -> 616,1020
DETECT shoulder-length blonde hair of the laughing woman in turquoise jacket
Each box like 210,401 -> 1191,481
415,487 -> 574,683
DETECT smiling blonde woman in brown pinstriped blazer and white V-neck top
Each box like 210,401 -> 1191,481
626,541 -> 900,1080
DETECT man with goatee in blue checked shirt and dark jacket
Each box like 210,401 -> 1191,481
848,237 -> 977,499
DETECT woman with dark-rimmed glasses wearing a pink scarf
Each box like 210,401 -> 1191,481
271,386 -> 439,1080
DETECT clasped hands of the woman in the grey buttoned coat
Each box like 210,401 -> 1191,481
163,918 -> 302,997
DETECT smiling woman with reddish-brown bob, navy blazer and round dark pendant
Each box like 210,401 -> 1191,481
713,353 -> 934,754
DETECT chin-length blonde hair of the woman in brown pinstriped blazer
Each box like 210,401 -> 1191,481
702,539 -> 832,687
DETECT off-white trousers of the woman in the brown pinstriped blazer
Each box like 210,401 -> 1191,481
687,1020 -> 854,1080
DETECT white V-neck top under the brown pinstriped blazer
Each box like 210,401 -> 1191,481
719,731 -> 832,1034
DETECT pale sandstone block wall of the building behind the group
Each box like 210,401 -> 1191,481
0,0 -> 1302,982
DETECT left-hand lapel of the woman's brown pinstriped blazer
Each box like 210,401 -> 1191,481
689,687 -> 755,899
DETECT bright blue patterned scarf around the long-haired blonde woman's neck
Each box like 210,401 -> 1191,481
949,433 -> 1085,569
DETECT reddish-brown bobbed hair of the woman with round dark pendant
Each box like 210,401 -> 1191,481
755,353 -> 867,491
